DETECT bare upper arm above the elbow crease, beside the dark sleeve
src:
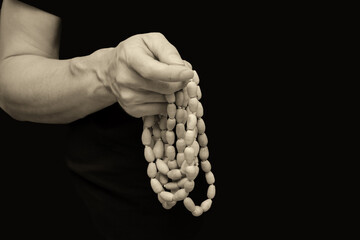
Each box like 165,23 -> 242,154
0,0 -> 60,59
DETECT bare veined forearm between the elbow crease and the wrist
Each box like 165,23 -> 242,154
0,49 -> 116,123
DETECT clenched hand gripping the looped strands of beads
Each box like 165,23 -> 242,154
105,33 -> 193,117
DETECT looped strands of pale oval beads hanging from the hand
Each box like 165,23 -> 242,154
141,71 -> 215,216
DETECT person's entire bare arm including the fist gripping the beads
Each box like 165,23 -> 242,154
0,0 -> 193,123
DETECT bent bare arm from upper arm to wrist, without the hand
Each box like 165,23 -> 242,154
0,0 -> 116,123
